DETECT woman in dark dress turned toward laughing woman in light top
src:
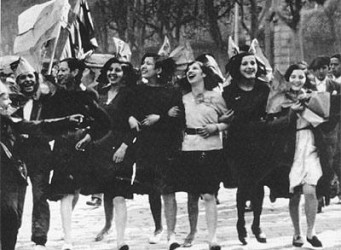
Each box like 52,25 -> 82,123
129,54 -> 184,247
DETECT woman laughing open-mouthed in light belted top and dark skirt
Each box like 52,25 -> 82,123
178,61 -> 233,250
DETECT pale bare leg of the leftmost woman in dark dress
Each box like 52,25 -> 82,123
60,194 -> 74,244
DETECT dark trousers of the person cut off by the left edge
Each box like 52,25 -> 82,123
1,168 -> 26,250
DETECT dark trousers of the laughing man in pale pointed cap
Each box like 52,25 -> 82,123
28,169 -> 50,245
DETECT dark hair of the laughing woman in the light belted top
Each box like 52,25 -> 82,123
179,61 -> 219,93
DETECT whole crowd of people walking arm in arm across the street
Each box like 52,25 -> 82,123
0,48 -> 341,250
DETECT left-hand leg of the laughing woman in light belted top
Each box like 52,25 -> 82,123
184,193 -> 199,247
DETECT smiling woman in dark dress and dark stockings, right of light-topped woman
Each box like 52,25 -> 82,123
223,53 -> 269,245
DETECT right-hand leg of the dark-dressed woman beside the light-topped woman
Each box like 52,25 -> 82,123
162,193 -> 177,240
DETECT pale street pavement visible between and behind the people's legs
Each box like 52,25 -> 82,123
16,184 -> 341,250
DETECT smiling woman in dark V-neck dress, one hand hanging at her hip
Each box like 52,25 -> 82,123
92,58 -> 138,250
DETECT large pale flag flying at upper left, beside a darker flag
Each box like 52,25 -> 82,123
13,0 -> 70,70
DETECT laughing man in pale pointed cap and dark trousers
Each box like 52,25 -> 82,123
15,58 -> 51,249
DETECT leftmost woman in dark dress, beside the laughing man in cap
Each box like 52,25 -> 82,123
41,58 -> 110,249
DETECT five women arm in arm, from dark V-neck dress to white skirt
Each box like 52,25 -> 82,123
1,48 -> 340,250
